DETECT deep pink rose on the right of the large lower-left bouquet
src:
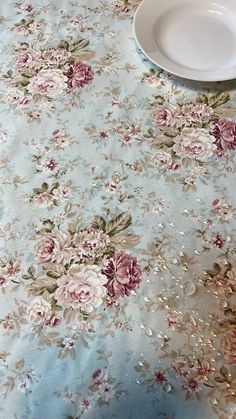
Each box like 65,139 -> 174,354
103,252 -> 141,297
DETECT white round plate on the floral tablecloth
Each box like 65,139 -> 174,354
134,0 -> 236,81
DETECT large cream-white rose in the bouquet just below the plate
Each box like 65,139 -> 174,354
173,128 -> 216,161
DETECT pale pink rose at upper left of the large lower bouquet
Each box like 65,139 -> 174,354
35,231 -> 74,264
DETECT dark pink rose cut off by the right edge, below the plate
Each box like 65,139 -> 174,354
211,119 -> 236,150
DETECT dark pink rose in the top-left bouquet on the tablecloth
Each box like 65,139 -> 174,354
64,61 -> 94,88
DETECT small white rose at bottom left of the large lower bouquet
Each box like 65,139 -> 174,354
27,297 -> 52,325
